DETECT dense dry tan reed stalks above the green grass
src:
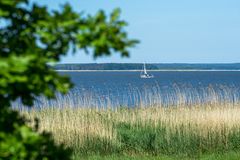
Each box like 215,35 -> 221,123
23,102 -> 240,148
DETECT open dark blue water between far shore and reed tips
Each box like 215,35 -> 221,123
66,71 -> 240,92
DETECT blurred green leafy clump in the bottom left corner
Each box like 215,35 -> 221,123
0,109 -> 72,160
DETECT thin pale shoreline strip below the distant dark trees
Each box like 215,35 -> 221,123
55,69 -> 240,72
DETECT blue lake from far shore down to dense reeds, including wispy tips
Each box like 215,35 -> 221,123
51,71 -> 240,107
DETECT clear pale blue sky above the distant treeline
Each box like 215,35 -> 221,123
32,0 -> 240,63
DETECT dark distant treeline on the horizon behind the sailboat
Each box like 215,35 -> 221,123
51,63 -> 240,70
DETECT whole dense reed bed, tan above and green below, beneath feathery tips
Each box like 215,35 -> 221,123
23,103 -> 240,159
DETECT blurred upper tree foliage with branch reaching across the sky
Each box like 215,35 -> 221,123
0,0 -> 137,106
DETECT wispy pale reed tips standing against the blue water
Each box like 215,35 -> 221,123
12,84 -> 240,109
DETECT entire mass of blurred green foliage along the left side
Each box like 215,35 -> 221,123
0,0 -> 137,159
